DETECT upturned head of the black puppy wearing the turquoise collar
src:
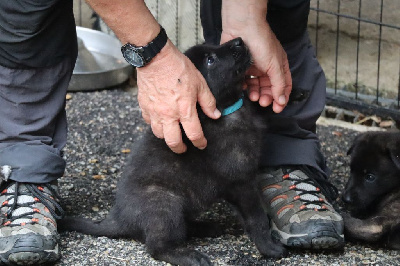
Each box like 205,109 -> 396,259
185,38 -> 251,109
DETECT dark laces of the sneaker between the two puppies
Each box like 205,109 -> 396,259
283,165 -> 338,211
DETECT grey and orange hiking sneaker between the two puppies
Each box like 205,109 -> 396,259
258,166 -> 344,249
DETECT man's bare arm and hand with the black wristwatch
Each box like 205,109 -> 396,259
87,0 -> 221,153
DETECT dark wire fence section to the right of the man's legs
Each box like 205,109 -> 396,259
309,0 -> 400,122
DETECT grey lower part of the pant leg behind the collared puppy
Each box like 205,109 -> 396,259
261,32 -> 329,175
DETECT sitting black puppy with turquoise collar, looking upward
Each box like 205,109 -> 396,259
61,38 -> 286,265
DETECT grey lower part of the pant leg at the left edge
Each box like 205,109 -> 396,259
0,57 -> 75,183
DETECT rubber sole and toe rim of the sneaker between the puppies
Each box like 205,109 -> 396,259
271,221 -> 344,250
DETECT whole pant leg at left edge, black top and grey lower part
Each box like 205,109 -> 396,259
0,0 -> 77,183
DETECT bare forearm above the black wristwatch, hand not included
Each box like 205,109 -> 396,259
86,0 -> 160,46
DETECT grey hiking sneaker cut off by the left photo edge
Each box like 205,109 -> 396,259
0,181 -> 64,265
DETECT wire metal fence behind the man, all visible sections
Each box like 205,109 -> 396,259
74,0 -> 400,123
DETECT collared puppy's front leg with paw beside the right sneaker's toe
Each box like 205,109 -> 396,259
226,183 -> 287,258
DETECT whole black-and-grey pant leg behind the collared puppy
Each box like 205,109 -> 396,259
201,0 -> 329,178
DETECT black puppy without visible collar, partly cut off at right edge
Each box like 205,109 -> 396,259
342,132 -> 400,249
